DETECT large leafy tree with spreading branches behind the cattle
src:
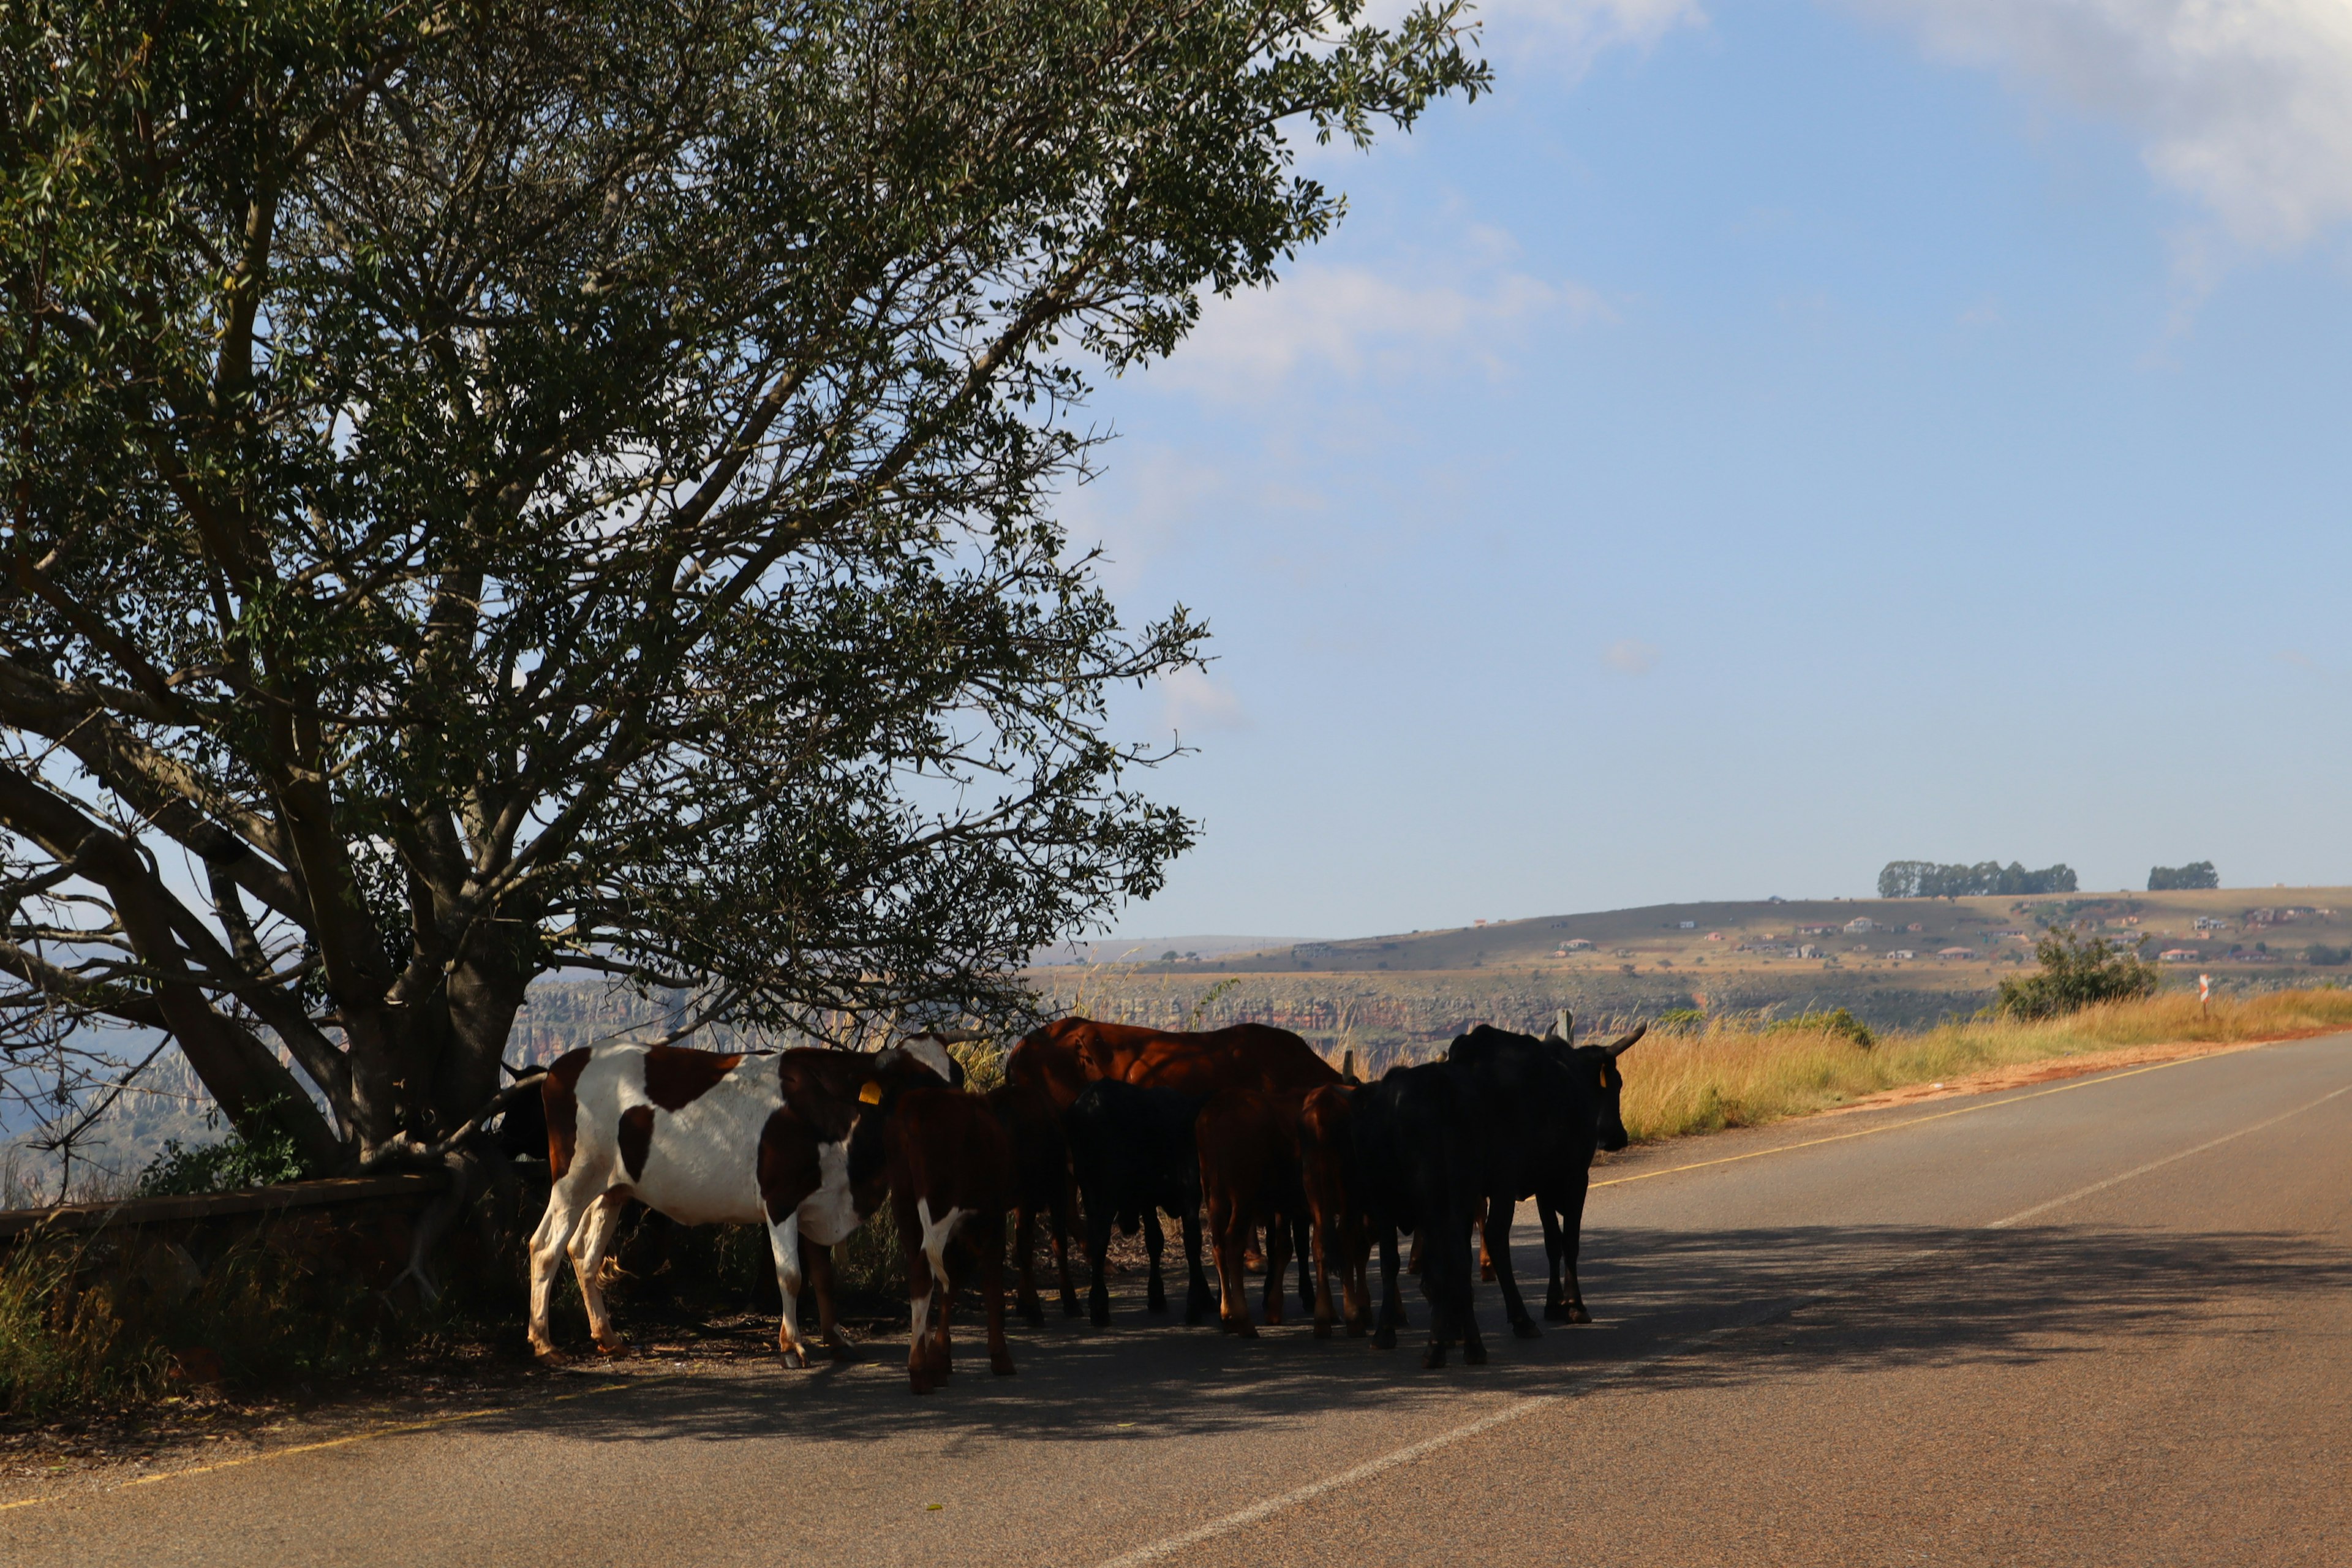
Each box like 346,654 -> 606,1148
0,0 -> 1487,1169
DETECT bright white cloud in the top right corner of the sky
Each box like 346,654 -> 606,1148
1844,0 -> 2352,249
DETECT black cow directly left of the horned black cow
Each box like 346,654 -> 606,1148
1350,1063 -> 1487,1366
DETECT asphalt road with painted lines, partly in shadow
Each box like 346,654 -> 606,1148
13,1037 -> 2352,1568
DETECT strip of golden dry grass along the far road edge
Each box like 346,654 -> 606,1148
1625,987 -> 2352,1140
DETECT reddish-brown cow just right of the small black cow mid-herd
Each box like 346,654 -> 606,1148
1195,1088 -> 1315,1340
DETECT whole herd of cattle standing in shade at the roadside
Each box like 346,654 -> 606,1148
529,1013 -> 1642,1394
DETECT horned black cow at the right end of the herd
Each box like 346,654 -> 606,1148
1447,1009 -> 1646,1340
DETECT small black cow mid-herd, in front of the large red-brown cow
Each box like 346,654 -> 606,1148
1063,1079 -> 1216,1326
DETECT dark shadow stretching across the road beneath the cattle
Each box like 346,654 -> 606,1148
484,1227 -> 2352,1441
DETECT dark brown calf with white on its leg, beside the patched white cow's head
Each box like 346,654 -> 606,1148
882,1088 -> 1019,1394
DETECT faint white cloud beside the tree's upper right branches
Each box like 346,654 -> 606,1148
1150,263 -> 1613,395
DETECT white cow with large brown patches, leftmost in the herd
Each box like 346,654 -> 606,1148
529,1037 -> 964,1366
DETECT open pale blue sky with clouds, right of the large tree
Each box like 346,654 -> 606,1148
1061,0 -> 2352,936
